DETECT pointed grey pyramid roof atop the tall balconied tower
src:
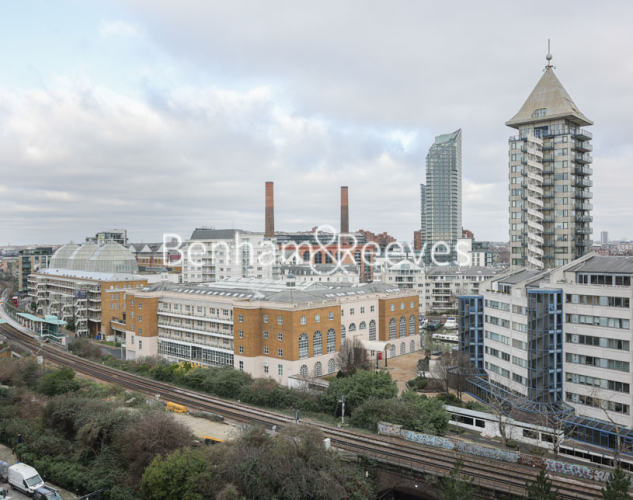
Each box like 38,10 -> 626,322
506,66 -> 593,129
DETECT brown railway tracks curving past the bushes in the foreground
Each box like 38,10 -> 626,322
0,325 -> 601,500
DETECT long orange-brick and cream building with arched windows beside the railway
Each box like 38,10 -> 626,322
126,278 -> 420,384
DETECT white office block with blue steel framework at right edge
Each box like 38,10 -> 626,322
459,254 -> 633,452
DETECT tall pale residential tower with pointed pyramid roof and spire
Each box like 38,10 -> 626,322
506,53 -> 593,269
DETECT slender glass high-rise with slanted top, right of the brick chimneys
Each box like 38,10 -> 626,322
420,129 -> 462,262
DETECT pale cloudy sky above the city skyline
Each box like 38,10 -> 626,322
0,0 -> 633,245
